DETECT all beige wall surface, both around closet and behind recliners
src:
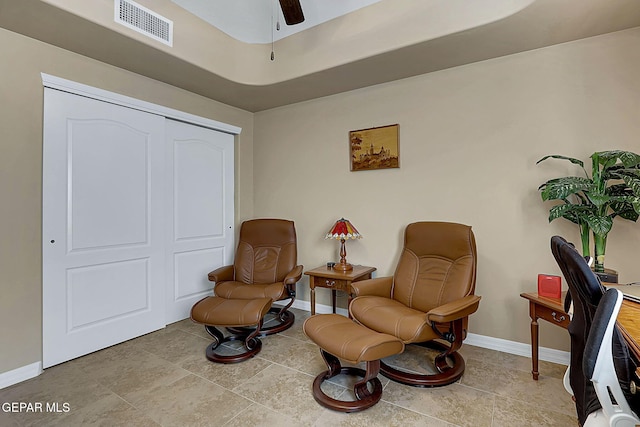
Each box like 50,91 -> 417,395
0,20 -> 640,373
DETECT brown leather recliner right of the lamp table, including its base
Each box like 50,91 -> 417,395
349,222 -> 480,387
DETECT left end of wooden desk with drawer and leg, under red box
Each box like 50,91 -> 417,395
520,291 -> 570,381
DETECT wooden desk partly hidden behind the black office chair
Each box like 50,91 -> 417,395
520,291 -> 640,380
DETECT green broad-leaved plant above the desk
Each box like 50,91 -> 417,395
536,150 -> 640,284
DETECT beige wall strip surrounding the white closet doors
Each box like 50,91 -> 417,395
0,29 -> 253,373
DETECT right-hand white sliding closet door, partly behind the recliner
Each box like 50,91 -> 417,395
166,120 -> 234,323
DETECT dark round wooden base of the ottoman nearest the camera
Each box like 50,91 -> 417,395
313,349 -> 382,413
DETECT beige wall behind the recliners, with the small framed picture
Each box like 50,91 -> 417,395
254,30 -> 640,350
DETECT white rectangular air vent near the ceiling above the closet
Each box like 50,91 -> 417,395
114,0 -> 173,46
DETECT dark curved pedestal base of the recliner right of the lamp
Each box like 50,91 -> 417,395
380,341 -> 465,387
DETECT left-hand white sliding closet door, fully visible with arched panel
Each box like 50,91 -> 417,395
42,88 -> 166,367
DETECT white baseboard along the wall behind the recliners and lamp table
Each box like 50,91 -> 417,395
292,300 -> 571,366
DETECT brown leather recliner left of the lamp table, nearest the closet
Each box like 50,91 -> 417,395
209,219 -> 302,336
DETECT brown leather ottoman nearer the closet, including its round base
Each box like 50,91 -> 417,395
191,296 -> 273,363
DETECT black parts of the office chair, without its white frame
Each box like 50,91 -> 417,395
551,236 -> 637,426
